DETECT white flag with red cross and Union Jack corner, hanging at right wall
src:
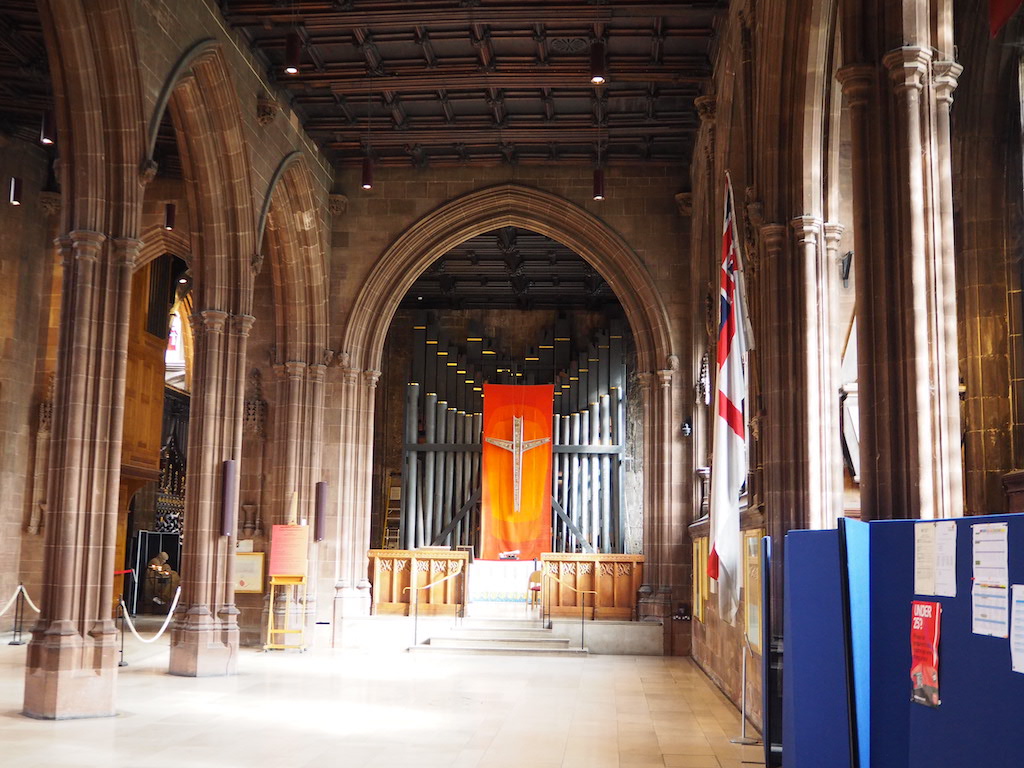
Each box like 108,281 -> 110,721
708,174 -> 754,624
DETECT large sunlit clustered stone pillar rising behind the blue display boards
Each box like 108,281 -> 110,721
839,51 -> 963,519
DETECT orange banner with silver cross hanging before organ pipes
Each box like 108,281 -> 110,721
481,384 -> 555,560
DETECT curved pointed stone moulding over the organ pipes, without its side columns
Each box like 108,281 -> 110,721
341,183 -> 672,371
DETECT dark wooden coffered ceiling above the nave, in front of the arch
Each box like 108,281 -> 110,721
227,0 -> 727,167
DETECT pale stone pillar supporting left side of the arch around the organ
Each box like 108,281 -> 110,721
334,366 -> 380,630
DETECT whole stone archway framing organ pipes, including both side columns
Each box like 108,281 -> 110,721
336,183 -> 684,616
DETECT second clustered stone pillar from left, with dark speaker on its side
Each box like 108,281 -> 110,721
169,309 -> 254,677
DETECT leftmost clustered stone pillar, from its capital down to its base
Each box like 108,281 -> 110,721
25,230 -> 140,719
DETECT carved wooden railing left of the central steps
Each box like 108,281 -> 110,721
368,549 -> 469,616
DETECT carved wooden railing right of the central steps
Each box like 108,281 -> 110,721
541,552 -> 644,621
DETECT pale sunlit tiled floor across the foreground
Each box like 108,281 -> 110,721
0,634 -> 760,768
